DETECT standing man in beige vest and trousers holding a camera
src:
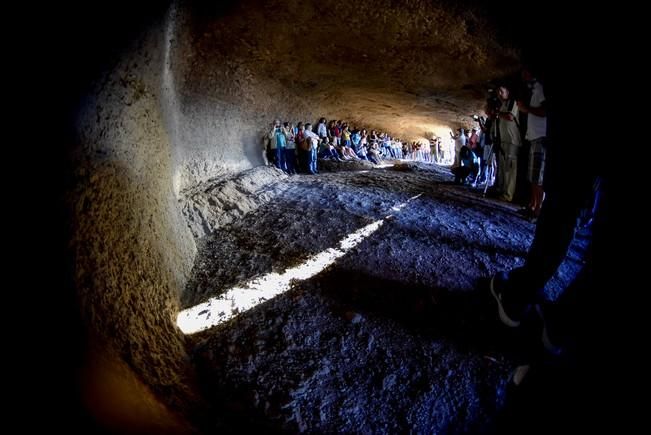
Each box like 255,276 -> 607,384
497,85 -> 522,202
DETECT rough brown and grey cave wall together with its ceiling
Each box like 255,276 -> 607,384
67,0 -> 517,431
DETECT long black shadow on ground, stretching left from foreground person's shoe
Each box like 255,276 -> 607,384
315,267 -> 541,360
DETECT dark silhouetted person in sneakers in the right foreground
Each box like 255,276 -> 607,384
490,63 -> 612,368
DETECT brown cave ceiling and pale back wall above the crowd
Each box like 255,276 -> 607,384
174,0 -> 516,189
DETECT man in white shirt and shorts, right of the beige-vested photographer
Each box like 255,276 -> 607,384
518,67 -> 547,219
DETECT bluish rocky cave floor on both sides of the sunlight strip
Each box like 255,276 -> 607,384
183,162 -> 592,433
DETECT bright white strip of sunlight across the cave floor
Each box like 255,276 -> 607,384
176,193 -> 422,334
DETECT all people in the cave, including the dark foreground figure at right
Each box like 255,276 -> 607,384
265,63 -> 609,426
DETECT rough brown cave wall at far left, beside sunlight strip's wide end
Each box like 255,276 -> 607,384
70,5 -> 196,430
